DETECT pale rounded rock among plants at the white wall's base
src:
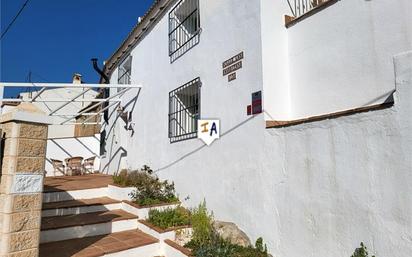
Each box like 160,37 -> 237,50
213,221 -> 252,247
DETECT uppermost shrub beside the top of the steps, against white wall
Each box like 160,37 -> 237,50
113,165 -> 179,206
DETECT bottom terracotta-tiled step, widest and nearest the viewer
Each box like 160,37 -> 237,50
40,230 -> 160,257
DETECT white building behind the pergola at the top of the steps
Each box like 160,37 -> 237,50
3,74 -> 100,176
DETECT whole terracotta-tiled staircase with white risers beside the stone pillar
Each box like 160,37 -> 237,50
39,175 -> 190,257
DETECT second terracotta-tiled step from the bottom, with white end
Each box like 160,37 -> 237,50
40,210 -> 138,243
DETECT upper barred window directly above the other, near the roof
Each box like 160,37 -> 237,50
169,0 -> 200,62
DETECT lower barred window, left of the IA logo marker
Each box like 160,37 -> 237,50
169,78 -> 201,143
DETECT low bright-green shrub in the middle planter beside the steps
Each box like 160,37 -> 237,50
148,206 -> 191,229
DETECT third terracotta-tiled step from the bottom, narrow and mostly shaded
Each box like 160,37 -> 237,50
42,197 -> 121,217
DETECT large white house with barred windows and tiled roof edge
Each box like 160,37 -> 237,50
101,0 -> 412,257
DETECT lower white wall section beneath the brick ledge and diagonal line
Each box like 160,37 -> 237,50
160,54 -> 412,257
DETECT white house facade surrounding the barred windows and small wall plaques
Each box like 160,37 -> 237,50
102,0 -> 262,173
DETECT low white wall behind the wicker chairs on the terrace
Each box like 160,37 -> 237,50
46,134 -> 100,176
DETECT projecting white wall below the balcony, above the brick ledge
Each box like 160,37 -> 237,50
284,0 -> 412,119
